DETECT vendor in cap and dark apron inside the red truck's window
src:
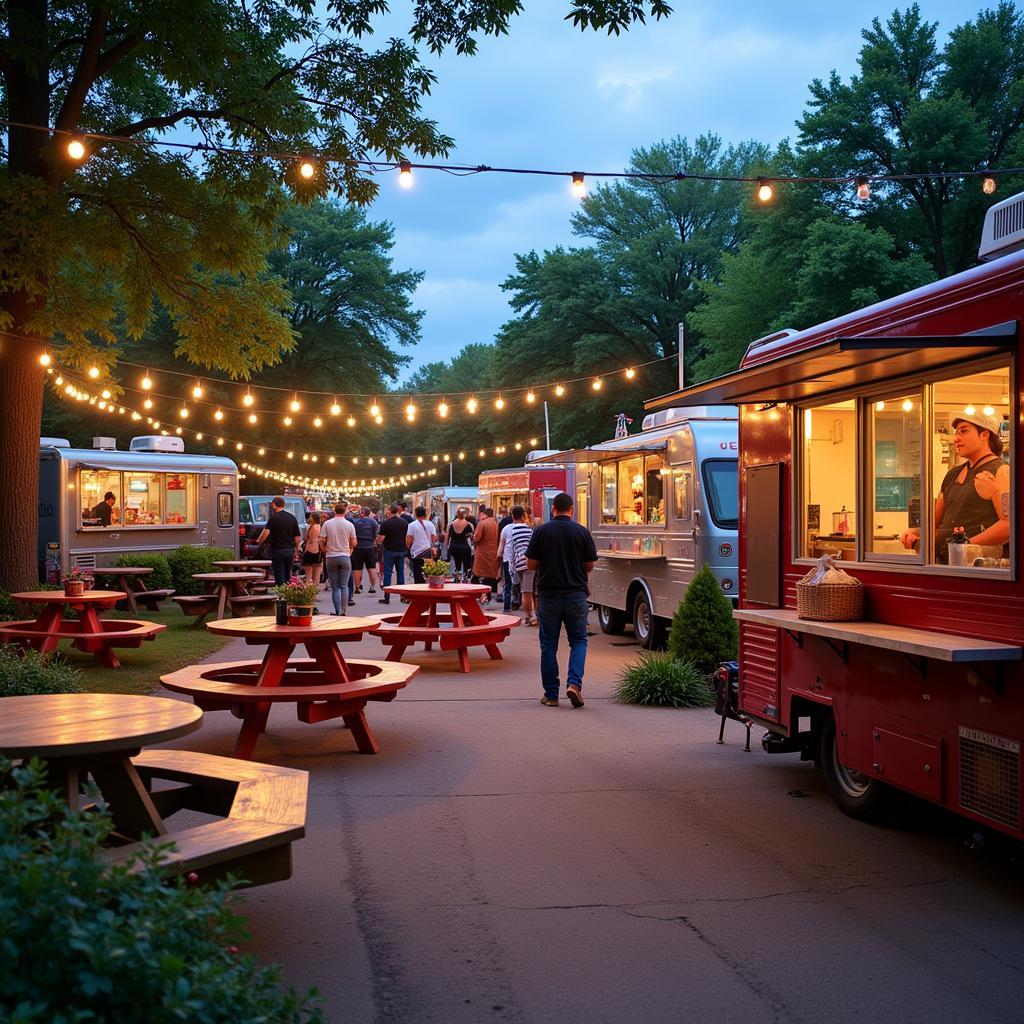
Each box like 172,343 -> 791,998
901,413 -> 1010,564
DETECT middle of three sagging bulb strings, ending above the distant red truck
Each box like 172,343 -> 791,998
54,367 -> 552,467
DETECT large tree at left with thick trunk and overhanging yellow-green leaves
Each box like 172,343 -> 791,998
0,0 -> 670,587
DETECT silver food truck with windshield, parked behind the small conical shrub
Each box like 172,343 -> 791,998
532,407 -> 738,648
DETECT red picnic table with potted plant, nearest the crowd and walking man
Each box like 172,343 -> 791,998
371,583 -> 519,672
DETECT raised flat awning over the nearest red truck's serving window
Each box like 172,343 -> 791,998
644,321 -> 1017,411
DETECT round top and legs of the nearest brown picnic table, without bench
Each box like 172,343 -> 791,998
0,693 -> 203,839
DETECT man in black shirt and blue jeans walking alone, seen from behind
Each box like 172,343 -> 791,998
526,494 -> 597,708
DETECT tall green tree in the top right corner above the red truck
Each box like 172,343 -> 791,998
798,0 -> 1024,278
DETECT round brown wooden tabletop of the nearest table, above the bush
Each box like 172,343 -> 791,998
0,693 -> 203,758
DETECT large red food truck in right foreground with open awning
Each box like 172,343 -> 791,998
647,196 -> 1024,838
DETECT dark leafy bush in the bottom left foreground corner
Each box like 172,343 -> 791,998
0,761 -> 323,1024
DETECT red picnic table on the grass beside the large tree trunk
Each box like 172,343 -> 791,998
0,590 -> 167,667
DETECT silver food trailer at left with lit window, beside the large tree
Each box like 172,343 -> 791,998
38,436 -> 239,582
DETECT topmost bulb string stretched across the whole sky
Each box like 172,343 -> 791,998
0,120 -> 1007,203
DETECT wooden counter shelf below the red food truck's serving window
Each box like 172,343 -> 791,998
732,608 -> 1024,662
